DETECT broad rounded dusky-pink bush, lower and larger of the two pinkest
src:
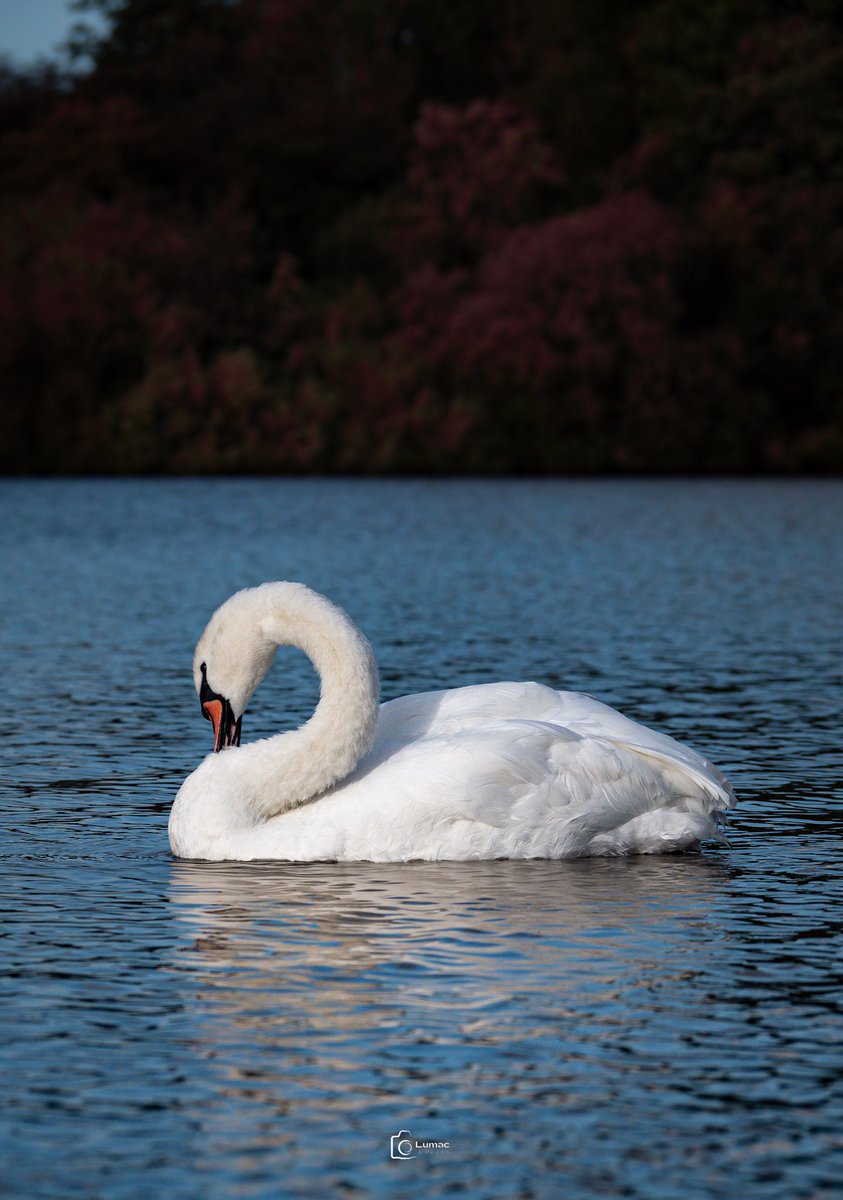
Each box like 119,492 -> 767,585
399,193 -> 678,408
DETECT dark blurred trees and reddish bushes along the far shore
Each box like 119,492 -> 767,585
0,0 -> 843,473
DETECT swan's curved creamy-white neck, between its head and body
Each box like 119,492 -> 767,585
234,584 -> 378,820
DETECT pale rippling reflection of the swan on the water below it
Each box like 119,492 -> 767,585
171,857 -> 731,1109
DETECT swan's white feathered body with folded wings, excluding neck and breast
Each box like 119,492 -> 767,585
244,683 -> 733,860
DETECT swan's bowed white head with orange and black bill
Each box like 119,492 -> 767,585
193,588 -> 277,751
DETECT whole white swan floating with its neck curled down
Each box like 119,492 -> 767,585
169,582 -> 734,862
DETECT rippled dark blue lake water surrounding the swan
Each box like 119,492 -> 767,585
0,481 -> 843,1200
